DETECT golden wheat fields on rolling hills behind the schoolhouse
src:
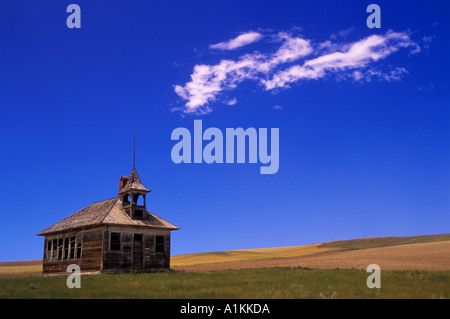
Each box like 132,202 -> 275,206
0,234 -> 450,276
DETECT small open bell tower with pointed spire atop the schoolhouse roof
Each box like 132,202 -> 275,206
118,135 -> 150,219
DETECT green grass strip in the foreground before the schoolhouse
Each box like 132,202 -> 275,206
0,268 -> 450,299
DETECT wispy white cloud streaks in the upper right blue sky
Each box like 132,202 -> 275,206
174,31 -> 420,113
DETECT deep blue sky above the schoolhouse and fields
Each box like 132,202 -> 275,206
0,0 -> 450,261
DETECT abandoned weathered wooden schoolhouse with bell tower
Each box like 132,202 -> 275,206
37,163 -> 179,274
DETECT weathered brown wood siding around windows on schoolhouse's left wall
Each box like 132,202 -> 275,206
43,229 -> 103,274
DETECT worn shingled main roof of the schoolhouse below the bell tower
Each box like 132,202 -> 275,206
37,196 -> 180,236
